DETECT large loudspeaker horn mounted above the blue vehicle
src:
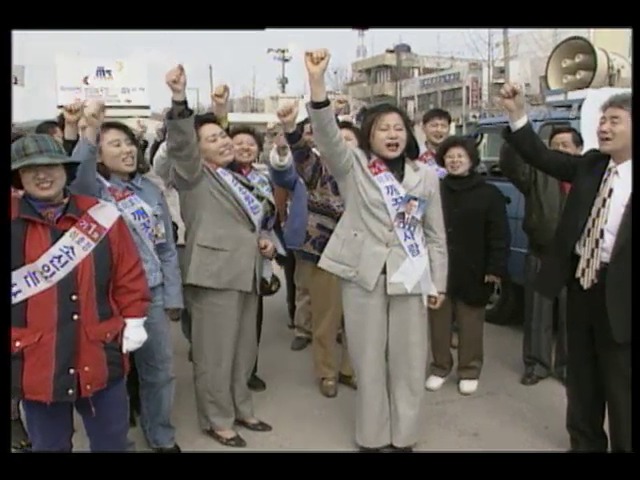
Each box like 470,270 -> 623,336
545,37 -> 631,91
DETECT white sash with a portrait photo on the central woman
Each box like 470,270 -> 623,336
368,158 -> 437,295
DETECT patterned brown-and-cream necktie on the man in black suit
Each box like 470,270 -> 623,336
576,164 -> 616,290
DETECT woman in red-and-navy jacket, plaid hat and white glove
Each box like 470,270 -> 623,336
11,135 -> 150,452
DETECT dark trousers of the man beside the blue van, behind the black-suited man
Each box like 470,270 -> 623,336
522,253 -> 567,377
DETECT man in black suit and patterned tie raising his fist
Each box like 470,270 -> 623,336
500,84 -> 632,452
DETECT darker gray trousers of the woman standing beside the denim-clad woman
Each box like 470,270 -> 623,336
185,285 -> 258,431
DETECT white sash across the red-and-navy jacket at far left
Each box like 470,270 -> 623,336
11,200 -> 120,305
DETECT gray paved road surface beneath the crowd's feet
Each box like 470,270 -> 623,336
75,274 -> 568,452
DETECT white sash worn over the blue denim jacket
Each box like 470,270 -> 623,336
98,175 -> 166,263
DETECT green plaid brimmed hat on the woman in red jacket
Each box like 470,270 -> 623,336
11,134 -> 77,171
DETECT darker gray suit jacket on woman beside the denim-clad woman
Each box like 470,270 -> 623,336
167,106 -> 262,292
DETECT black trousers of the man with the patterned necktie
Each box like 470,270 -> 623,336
567,259 -> 632,452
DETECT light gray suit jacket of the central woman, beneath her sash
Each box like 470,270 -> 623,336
308,106 -> 448,295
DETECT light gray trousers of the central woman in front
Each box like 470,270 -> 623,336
342,275 -> 428,448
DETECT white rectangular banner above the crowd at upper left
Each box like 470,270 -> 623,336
56,56 -> 151,117
